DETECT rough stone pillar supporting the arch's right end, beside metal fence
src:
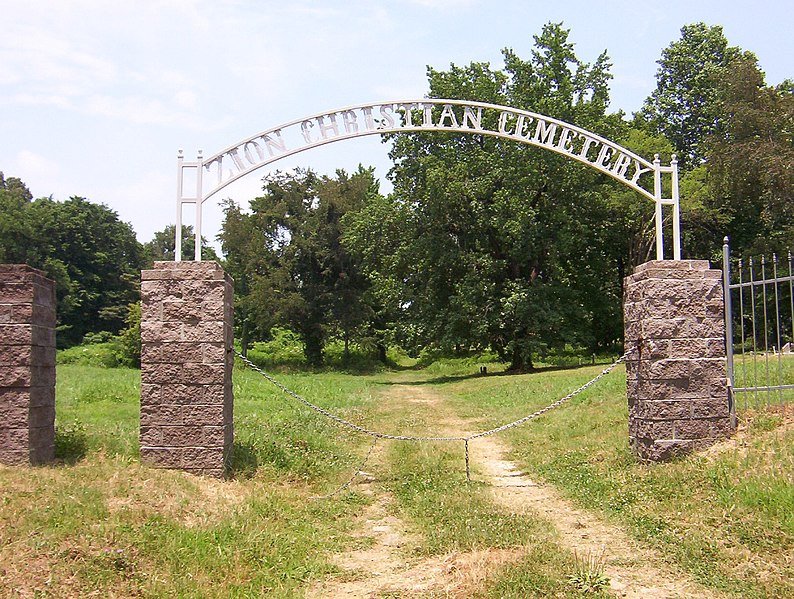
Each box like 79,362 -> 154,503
624,260 -> 732,461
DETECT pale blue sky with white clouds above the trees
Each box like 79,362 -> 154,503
0,0 -> 794,248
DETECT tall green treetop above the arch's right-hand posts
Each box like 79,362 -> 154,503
637,23 -> 741,170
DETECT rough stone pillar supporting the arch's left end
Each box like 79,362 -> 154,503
141,262 -> 234,477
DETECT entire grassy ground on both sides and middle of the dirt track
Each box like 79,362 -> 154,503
0,362 -> 794,597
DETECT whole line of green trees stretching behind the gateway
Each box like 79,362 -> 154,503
0,23 -> 794,369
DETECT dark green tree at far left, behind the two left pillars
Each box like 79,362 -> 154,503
0,178 -> 143,346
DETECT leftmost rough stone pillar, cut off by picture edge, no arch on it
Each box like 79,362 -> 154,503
0,264 -> 55,464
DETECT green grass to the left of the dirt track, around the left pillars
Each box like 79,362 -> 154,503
0,365 -> 378,597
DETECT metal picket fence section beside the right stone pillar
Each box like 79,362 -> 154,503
722,237 -> 794,416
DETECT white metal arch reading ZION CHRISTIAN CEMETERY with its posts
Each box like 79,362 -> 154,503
174,98 -> 681,261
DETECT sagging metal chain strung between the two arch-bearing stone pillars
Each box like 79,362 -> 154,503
234,350 -> 626,442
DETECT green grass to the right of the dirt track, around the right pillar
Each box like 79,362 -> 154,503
444,367 -> 794,597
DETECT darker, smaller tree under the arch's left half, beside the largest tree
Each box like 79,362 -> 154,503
220,167 -> 377,366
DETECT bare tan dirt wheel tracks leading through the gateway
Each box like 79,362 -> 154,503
307,384 -> 720,599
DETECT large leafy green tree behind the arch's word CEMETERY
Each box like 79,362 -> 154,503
351,24 -> 626,369
